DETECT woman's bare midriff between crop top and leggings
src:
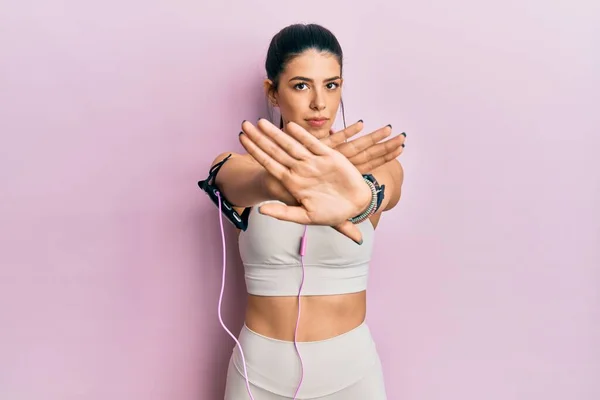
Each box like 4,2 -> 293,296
246,291 -> 367,342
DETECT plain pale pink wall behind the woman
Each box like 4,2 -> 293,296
0,0 -> 600,400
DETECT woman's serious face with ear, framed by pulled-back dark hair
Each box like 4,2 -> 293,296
265,50 -> 342,139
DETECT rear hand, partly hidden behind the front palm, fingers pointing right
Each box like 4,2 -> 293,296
321,121 -> 406,174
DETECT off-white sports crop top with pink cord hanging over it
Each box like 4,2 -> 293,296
239,200 -> 375,296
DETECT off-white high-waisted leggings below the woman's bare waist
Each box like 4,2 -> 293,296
225,323 -> 387,400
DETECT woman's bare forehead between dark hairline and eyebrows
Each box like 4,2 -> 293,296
283,50 -> 341,79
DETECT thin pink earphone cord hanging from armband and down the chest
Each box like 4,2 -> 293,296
214,191 -> 308,400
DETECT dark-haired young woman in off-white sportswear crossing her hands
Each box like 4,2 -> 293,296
213,24 -> 406,400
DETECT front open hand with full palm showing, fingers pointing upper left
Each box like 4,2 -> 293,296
240,119 -> 371,243
